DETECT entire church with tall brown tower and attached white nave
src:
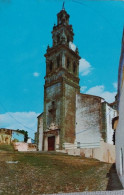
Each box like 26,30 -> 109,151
37,5 -> 117,162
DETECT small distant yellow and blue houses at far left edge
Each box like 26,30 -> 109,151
0,128 -> 24,144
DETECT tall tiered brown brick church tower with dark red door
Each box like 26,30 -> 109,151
43,5 -> 80,151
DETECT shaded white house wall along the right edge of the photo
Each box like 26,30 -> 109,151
116,83 -> 124,187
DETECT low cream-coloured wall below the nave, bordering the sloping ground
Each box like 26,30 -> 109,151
66,141 -> 115,163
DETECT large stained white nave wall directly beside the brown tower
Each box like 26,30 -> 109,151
76,94 -> 101,148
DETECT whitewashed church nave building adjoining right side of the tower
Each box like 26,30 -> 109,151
76,94 -> 117,148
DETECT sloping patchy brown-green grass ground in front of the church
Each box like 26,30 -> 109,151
0,149 -> 111,194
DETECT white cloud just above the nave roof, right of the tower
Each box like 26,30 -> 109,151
85,85 -> 117,103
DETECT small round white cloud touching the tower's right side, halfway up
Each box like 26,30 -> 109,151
79,58 -> 92,76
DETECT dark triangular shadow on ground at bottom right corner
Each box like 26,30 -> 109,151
106,163 -> 123,191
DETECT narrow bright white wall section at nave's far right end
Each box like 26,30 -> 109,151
106,104 -> 117,144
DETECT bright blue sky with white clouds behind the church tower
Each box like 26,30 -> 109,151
0,0 -> 124,138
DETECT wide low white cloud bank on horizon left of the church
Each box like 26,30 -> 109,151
0,112 -> 39,138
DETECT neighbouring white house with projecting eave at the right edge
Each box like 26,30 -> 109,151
113,30 -> 124,187
